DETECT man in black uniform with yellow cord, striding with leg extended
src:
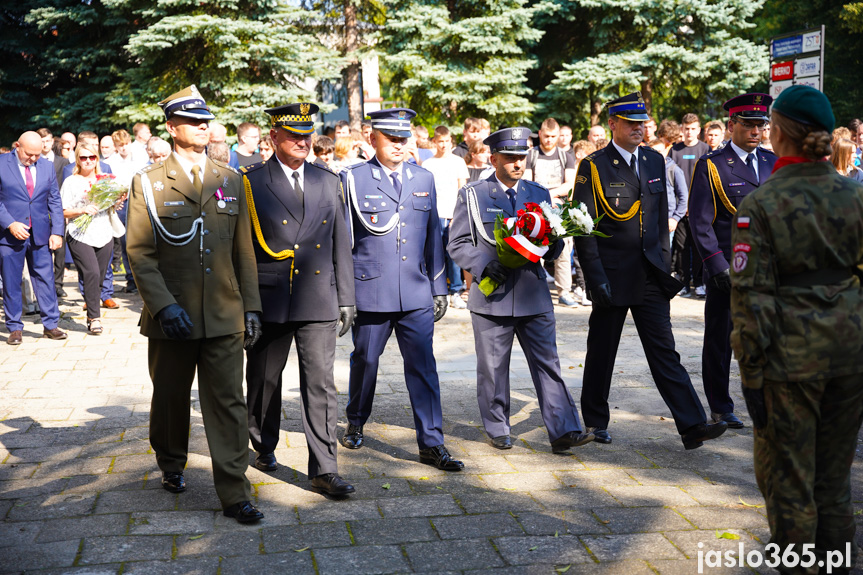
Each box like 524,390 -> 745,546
574,92 -> 727,449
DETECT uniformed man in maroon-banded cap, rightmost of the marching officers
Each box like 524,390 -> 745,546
689,93 -> 776,429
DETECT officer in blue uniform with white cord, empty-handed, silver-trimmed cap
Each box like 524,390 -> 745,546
340,108 -> 464,471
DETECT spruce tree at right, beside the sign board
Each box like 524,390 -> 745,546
541,0 -> 768,134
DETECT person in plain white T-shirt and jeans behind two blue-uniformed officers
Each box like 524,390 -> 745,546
422,126 -> 468,309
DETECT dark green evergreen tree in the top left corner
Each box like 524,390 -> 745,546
0,0 -> 136,141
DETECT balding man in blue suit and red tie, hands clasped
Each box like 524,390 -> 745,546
0,132 -> 66,345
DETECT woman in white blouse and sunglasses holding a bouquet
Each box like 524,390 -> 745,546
60,144 -> 126,335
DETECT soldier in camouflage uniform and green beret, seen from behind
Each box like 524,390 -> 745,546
731,86 -> 863,573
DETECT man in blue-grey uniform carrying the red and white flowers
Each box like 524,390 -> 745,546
447,128 -> 593,453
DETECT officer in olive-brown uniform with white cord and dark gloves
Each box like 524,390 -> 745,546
127,86 -> 263,523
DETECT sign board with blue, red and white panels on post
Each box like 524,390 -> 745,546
770,26 -> 824,98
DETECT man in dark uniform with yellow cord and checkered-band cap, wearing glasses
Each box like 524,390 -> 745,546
241,103 -> 355,496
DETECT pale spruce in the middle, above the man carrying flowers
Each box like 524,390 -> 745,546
380,0 -> 544,129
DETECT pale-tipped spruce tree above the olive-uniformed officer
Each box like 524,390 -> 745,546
109,0 -> 343,130
